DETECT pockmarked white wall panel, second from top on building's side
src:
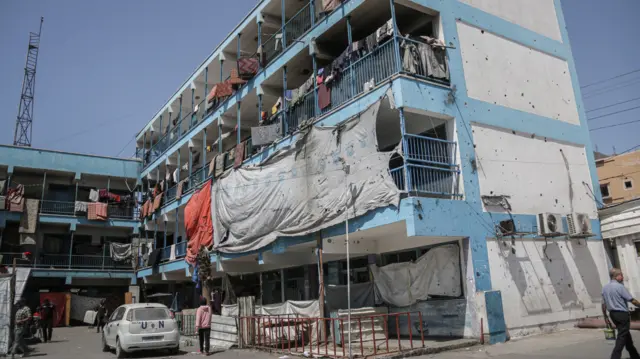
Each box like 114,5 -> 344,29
457,22 -> 580,125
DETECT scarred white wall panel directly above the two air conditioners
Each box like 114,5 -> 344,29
472,124 -> 598,219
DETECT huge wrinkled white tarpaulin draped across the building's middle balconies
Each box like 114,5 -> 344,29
211,95 -> 400,253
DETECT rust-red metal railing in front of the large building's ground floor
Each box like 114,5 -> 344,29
238,312 -> 425,358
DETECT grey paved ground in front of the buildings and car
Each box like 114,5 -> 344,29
18,327 -> 640,359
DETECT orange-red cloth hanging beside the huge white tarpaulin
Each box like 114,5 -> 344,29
184,180 -> 213,264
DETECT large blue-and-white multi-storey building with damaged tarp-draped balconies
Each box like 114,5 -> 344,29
132,0 -> 608,342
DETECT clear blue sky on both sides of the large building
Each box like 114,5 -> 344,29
0,0 -> 640,157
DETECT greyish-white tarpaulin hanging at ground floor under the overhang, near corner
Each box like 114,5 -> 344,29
370,244 -> 462,307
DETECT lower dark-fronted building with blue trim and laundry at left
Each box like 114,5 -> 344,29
0,145 -> 140,307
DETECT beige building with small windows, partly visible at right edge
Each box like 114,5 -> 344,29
595,150 -> 640,205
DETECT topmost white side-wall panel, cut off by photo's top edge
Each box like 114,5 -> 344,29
460,0 -> 562,42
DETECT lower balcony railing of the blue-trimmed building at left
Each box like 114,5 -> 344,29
2,253 -> 132,271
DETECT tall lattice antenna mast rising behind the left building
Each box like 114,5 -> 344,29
13,17 -> 44,147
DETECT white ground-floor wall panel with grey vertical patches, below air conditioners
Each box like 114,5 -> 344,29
487,238 -> 609,337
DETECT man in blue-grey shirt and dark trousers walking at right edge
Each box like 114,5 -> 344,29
602,268 -> 640,359
